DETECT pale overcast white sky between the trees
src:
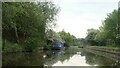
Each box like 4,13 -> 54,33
53,0 -> 119,38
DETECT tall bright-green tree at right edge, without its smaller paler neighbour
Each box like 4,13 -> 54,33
96,10 -> 119,45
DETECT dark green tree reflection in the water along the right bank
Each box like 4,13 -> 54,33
84,51 -> 120,66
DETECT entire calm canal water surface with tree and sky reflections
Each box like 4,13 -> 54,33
2,47 -> 120,67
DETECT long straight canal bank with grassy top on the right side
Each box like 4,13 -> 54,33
84,46 -> 120,60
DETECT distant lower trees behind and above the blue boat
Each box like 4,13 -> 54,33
45,30 -> 80,48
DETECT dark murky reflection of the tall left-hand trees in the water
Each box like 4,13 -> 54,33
2,53 -> 44,66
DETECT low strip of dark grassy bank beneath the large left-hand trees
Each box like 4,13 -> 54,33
1,41 -> 43,52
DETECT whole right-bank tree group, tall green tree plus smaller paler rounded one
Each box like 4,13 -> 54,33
86,9 -> 120,47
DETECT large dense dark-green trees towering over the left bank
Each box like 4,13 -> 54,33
2,2 -> 58,51
